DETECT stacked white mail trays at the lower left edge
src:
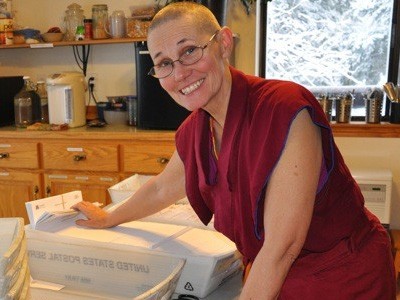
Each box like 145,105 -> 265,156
0,218 -> 30,300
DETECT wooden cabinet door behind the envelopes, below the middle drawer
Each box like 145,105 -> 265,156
44,173 -> 119,205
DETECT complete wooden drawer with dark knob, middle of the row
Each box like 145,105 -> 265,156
43,141 -> 118,172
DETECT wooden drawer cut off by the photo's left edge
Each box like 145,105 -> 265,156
0,141 -> 39,169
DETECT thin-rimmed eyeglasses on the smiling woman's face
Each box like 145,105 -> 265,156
147,30 -> 219,79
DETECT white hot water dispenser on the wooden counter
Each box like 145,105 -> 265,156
46,72 -> 87,128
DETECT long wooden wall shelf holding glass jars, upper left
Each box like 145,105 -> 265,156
0,37 -> 146,49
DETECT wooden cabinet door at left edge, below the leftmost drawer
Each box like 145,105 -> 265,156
0,171 -> 43,224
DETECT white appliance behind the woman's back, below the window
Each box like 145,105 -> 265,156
351,169 -> 393,229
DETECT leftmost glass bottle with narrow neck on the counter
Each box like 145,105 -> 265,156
14,76 -> 33,128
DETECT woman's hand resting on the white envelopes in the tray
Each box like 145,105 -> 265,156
71,201 -> 111,228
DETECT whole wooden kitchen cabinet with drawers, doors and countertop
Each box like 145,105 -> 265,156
0,125 -> 175,223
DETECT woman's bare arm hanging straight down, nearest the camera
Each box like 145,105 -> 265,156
240,110 -> 322,300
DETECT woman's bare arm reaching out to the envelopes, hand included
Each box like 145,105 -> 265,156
73,151 -> 185,228
